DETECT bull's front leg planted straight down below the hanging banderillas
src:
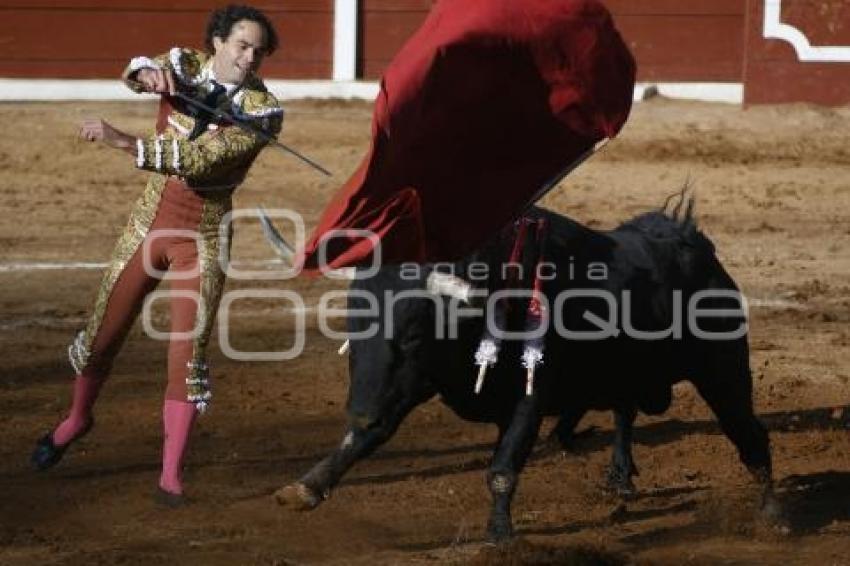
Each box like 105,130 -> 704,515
487,393 -> 542,542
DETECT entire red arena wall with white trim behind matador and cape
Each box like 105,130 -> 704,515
0,0 -> 850,105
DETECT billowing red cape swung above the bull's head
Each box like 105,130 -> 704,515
299,0 -> 635,273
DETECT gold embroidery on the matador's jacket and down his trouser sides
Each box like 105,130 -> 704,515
79,48 -> 283,411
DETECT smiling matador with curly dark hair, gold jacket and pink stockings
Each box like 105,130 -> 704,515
32,6 -> 283,506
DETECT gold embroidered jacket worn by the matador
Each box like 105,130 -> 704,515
122,47 -> 283,190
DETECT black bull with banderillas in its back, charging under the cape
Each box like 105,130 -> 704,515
276,202 -> 772,540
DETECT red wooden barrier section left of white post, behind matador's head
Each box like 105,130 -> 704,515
0,0 -> 333,79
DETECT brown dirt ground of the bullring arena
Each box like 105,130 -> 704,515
0,99 -> 850,565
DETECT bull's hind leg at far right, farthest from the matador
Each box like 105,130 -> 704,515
695,369 -> 781,520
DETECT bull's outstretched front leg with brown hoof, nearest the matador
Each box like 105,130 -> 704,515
274,402 -> 419,510
